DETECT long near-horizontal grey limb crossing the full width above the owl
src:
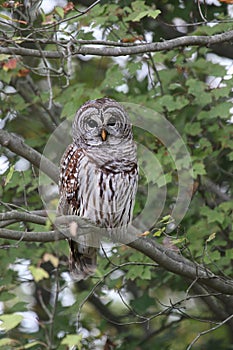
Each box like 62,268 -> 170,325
0,30 -> 233,59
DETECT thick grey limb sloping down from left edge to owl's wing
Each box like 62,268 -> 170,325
0,130 -> 58,183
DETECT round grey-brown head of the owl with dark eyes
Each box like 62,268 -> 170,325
72,97 -> 133,147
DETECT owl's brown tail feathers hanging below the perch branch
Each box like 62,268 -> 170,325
69,240 -> 97,281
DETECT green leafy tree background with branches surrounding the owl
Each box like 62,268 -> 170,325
0,0 -> 233,350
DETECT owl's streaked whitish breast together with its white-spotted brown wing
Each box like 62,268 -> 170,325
59,145 -> 138,227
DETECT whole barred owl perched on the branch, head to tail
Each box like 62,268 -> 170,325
58,98 -> 138,280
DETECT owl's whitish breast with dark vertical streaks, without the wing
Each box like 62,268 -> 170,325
77,157 -> 138,227
